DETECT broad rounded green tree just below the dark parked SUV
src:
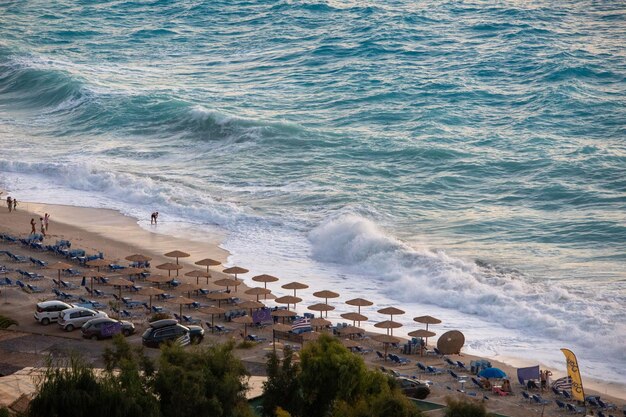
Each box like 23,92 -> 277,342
153,343 -> 251,417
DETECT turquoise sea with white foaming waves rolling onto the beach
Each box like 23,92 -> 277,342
0,0 -> 626,383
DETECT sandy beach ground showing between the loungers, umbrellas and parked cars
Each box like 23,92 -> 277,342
0,202 -> 626,416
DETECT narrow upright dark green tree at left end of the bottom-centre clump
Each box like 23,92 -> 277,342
263,347 -> 302,416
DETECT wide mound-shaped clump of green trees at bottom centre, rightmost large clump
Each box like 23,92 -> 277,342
263,335 -> 422,417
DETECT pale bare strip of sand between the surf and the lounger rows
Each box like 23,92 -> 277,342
0,202 -> 626,400
